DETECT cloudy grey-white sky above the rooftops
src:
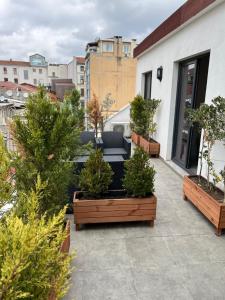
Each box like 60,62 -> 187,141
0,0 -> 185,63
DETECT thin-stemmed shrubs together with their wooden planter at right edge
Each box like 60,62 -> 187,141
183,97 -> 225,235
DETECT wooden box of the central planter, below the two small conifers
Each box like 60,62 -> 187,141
73,192 -> 157,230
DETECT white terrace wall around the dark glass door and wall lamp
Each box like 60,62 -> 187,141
136,0 -> 225,184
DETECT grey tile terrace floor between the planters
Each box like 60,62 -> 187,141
65,159 -> 225,300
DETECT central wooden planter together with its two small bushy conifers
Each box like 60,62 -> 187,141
73,148 -> 156,230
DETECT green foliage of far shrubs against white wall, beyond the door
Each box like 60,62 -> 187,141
130,95 -> 161,138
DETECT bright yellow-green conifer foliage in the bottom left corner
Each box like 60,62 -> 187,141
0,181 -> 71,300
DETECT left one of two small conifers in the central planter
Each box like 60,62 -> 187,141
79,149 -> 113,198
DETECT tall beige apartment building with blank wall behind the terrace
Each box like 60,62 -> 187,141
85,36 -> 136,113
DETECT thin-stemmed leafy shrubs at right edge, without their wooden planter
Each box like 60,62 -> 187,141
188,97 -> 225,190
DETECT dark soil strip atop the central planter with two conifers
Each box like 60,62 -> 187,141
77,190 -> 153,200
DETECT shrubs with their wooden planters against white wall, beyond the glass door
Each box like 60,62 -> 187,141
131,95 -> 161,157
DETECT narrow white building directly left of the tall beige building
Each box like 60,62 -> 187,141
68,56 -> 85,101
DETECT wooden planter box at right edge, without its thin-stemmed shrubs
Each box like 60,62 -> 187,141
183,176 -> 225,235
